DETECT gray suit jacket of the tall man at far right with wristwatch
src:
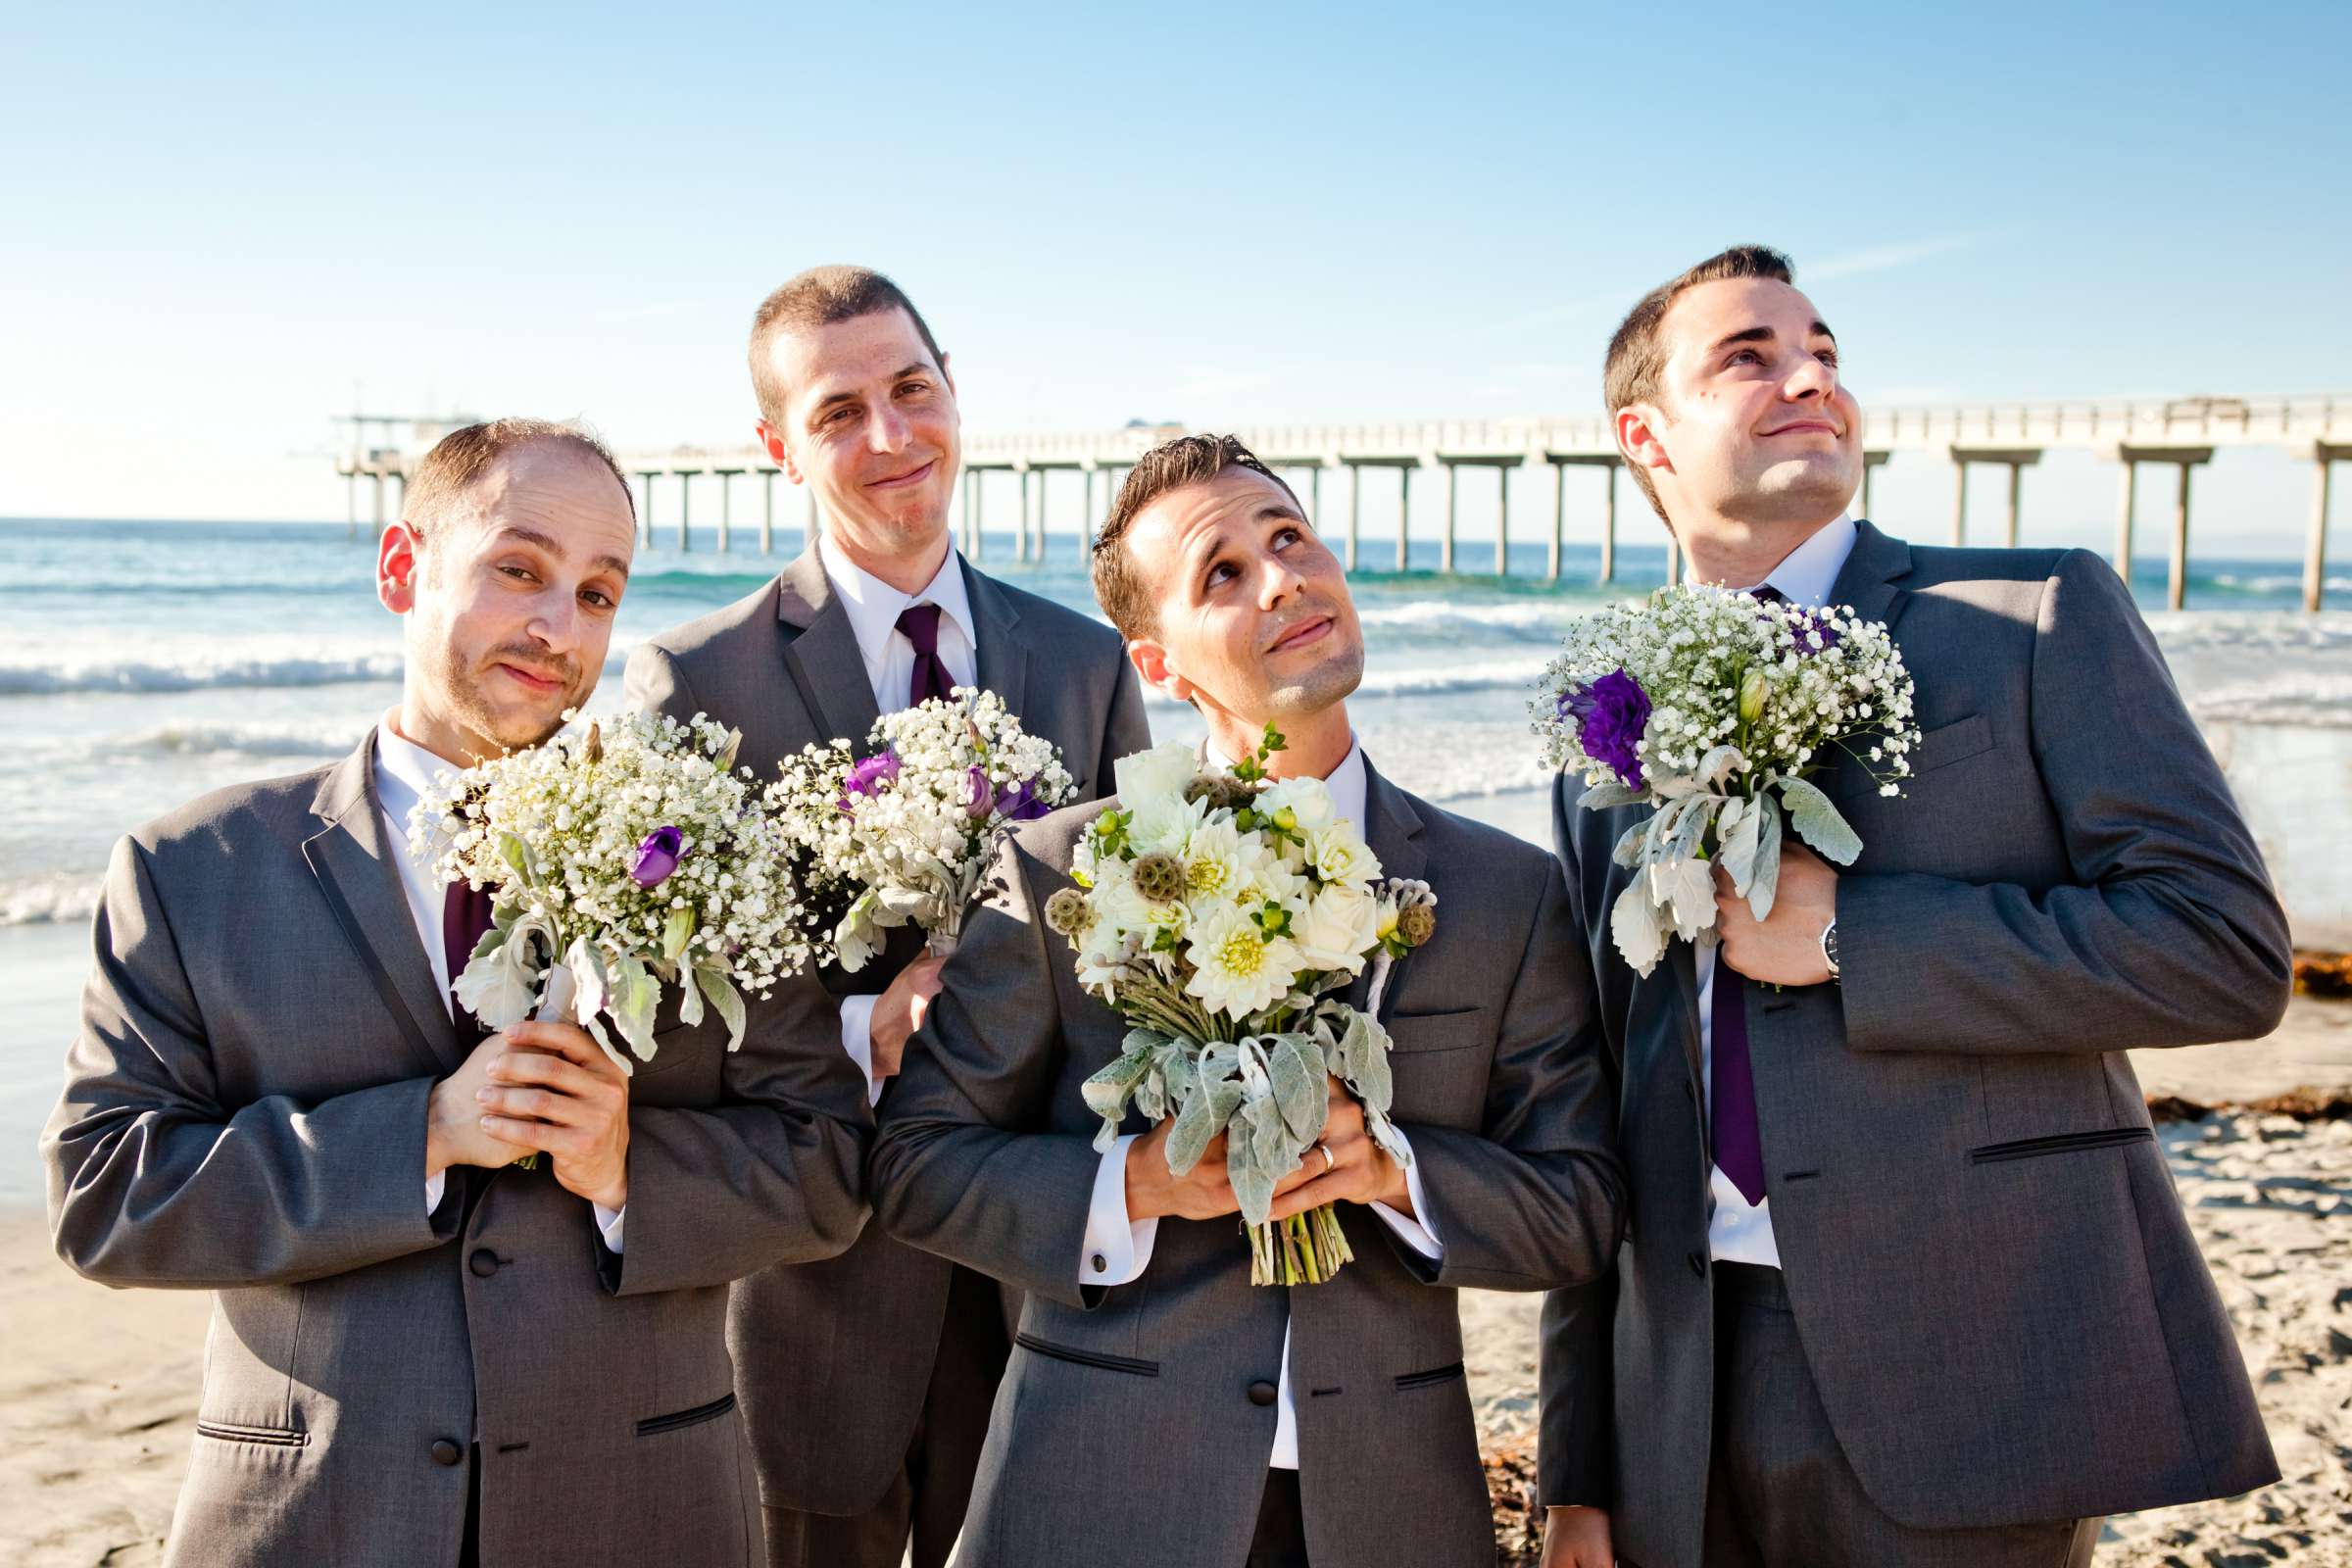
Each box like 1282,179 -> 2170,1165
1543,522 -> 2288,1568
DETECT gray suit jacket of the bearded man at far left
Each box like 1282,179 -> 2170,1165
42,738 -> 870,1568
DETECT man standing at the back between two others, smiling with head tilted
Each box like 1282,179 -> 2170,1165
628,268 -> 1151,1568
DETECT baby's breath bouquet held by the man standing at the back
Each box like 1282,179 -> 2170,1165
774,686 -> 1077,971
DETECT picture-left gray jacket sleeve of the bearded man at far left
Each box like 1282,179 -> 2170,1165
40,839 -> 461,1289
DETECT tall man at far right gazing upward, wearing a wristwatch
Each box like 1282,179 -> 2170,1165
1543,247 -> 2288,1568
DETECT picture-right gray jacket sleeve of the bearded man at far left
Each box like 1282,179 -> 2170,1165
600,976 -> 872,1296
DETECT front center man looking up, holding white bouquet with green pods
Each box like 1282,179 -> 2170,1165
872,437 -> 1621,1568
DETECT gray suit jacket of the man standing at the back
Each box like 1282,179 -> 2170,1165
628,548 -> 1151,1514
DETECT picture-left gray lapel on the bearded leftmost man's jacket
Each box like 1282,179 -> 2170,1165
301,731 -> 466,1074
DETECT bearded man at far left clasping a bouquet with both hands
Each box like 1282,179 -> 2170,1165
42,420 -> 870,1568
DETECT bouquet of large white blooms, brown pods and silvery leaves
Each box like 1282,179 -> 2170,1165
1062,726 -> 1437,1286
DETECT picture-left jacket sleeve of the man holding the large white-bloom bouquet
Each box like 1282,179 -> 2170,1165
872,837 -> 1103,1307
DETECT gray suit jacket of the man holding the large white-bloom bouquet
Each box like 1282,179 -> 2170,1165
872,752 -> 1623,1568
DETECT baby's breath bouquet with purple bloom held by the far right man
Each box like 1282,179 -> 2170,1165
1534,583 -> 1919,976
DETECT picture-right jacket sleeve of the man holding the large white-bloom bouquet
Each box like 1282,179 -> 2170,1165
1397,862 -> 1625,1291
